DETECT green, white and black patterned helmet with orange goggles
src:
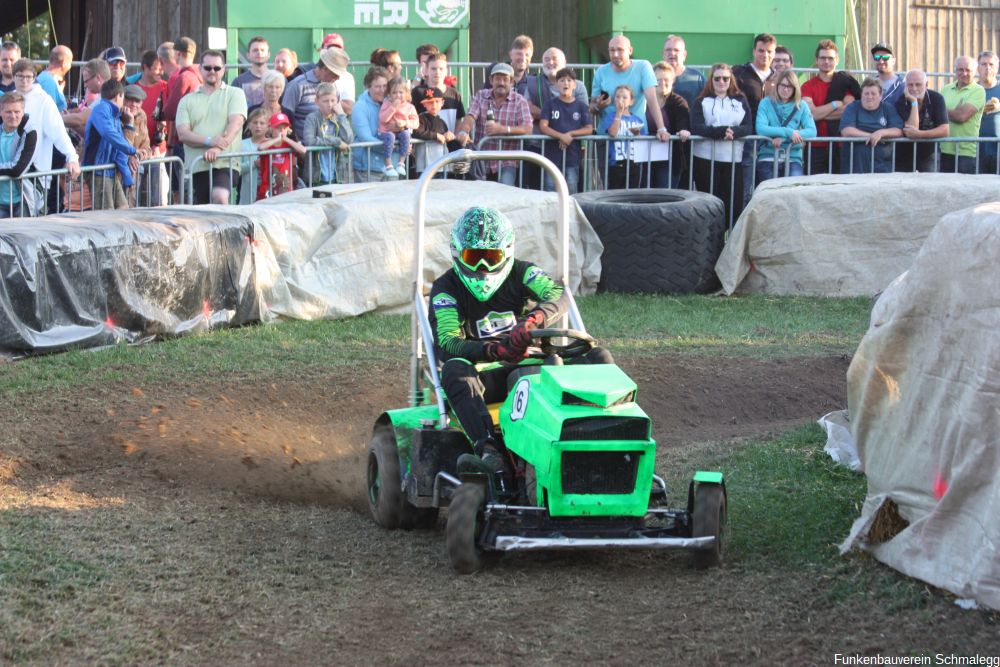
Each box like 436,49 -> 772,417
451,206 -> 514,301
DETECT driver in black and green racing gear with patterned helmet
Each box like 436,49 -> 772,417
430,206 -> 614,475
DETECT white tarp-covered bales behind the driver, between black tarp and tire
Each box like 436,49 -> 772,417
249,180 -> 603,319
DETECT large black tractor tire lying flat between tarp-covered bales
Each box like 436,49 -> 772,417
573,189 -> 726,294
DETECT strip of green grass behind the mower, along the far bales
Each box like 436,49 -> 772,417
0,295 -> 869,393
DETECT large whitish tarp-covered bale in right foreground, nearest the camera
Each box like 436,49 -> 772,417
842,204 -> 1000,609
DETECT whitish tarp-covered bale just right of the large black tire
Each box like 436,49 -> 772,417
715,174 -> 1000,296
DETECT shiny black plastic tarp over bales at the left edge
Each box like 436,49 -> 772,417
0,207 -> 260,356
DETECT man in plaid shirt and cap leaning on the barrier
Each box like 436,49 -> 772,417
455,63 -> 531,185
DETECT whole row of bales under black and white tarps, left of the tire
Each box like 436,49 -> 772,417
0,181 -> 603,355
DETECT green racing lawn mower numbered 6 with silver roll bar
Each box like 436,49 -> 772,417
367,150 -> 726,573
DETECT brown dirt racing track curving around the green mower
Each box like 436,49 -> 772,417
0,357 -> 992,664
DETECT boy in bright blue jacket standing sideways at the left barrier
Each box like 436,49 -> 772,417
83,79 -> 139,209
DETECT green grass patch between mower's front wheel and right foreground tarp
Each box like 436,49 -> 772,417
712,424 -> 935,613
